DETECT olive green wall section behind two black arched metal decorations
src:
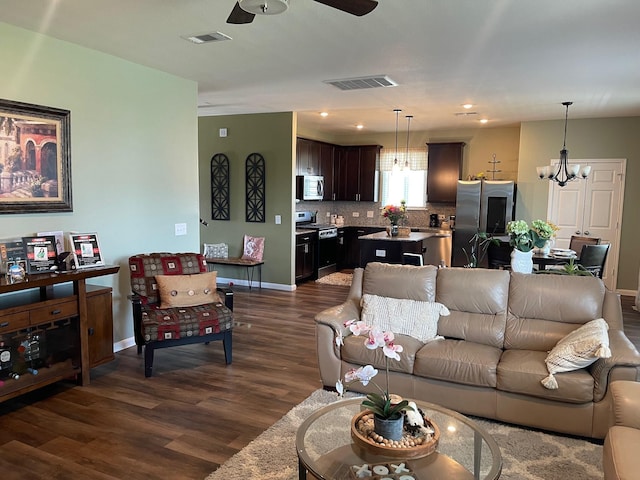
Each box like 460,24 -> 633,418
198,112 -> 296,290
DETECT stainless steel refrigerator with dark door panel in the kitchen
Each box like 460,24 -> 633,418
452,180 -> 516,267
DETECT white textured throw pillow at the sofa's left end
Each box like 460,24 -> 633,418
360,293 -> 449,342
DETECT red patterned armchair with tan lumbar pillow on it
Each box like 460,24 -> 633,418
129,253 -> 233,377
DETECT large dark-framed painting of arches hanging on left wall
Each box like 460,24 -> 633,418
0,99 -> 73,214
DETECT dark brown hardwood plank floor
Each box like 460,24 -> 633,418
0,282 -> 640,480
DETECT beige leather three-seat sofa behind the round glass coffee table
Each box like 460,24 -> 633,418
316,262 -> 640,439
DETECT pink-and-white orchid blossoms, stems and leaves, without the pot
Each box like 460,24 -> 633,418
336,320 -> 411,419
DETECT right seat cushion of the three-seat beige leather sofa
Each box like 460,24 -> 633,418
497,350 -> 594,404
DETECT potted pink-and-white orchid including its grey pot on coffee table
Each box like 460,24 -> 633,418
336,320 -> 412,440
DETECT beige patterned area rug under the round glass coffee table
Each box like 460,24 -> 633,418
205,390 -> 603,480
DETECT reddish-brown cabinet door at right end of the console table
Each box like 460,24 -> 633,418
87,288 -> 114,368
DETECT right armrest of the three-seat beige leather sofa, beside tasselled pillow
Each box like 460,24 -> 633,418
590,329 -> 640,402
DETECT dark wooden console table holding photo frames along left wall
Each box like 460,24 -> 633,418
0,266 -> 120,402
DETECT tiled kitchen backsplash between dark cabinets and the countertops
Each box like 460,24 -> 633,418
296,202 -> 456,227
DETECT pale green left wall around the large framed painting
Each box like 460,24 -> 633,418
0,23 -> 200,342
